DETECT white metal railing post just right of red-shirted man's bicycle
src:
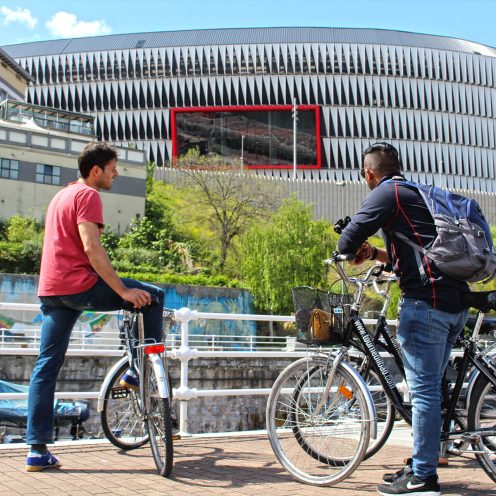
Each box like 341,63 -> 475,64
171,308 -> 198,437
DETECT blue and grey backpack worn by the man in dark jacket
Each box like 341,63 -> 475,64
386,179 -> 496,282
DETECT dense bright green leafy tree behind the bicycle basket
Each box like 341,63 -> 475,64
241,196 -> 336,314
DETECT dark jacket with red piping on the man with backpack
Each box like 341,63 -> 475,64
338,176 -> 468,313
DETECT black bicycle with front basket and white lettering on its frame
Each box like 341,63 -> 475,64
267,254 -> 496,485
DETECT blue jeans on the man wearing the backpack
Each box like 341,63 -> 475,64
398,298 -> 467,478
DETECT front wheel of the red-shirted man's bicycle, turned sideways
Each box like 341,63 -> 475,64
100,362 -> 148,450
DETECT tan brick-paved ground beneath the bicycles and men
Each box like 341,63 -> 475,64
0,435 -> 496,496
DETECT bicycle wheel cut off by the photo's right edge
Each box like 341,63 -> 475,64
467,374 -> 496,482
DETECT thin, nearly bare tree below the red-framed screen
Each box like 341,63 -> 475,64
176,149 -> 279,270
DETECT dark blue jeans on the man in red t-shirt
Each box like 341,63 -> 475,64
26,279 -> 164,444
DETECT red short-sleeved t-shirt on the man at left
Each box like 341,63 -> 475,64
38,182 -> 103,296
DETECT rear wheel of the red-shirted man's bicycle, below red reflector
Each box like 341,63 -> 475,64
143,355 -> 173,477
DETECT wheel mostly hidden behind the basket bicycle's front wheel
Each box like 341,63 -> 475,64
361,370 -> 396,460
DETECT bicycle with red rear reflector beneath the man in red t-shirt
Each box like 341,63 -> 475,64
97,297 -> 177,477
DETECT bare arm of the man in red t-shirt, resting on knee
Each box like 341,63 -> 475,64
78,222 -> 151,308
